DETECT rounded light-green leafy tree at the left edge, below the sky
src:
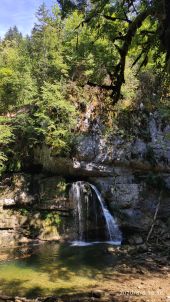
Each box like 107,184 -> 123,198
0,40 -> 36,112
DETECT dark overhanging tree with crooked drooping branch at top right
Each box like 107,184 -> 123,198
59,0 -> 170,103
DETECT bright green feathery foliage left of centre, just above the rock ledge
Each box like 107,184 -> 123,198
34,83 -> 75,155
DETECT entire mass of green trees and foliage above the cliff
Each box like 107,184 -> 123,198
0,0 -> 170,171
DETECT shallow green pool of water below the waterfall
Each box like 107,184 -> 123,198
0,244 -> 117,297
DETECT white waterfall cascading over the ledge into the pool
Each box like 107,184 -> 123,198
70,181 -> 122,245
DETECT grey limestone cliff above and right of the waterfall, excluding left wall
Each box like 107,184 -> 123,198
32,112 -> 170,244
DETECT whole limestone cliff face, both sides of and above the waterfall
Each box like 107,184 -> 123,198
0,112 -> 170,244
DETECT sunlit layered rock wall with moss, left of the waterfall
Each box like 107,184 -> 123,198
0,174 -> 72,247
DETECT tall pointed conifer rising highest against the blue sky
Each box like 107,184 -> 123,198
30,4 -> 67,89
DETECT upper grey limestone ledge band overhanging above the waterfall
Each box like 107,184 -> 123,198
34,112 -> 170,176
